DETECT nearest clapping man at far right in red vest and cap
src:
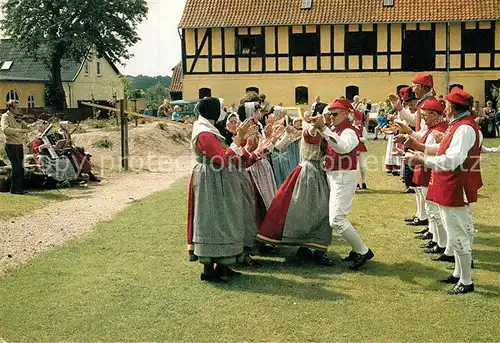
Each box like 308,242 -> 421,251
405,87 -> 482,294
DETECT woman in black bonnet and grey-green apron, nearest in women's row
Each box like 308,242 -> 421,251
188,98 -> 268,281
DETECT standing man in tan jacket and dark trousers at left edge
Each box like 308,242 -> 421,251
1,100 -> 29,194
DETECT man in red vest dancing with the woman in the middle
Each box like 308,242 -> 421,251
312,99 -> 374,270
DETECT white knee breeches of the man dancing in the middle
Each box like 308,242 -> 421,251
326,170 -> 357,235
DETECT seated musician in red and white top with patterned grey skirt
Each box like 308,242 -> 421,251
31,122 -> 78,184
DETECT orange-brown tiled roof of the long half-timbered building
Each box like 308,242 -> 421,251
179,0 -> 500,28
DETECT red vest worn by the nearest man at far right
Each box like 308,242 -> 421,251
427,115 -> 483,207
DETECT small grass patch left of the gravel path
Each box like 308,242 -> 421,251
0,190 -> 69,220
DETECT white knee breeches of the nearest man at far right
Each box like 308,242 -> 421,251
438,205 -> 475,256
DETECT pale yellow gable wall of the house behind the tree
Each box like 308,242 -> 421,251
63,55 -> 124,108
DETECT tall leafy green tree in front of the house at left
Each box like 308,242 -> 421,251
0,0 -> 148,110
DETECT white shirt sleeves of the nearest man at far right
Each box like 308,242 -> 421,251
424,125 -> 483,171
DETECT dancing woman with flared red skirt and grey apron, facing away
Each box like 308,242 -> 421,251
257,117 -> 333,265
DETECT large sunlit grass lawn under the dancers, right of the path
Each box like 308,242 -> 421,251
0,140 -> 500,342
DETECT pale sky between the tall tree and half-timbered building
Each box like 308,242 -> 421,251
117,0 -> 186,76
